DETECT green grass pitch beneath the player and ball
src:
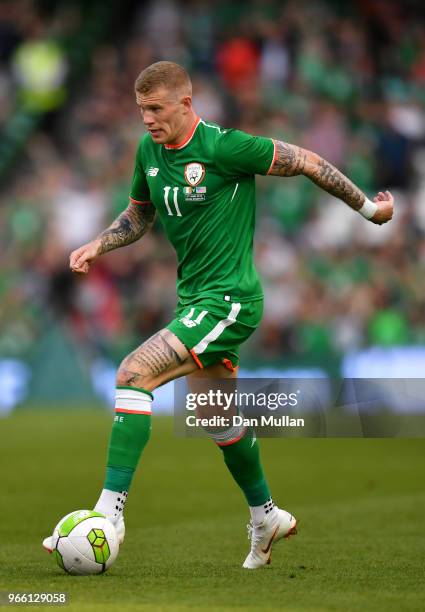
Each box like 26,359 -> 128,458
0,411 -> 425,612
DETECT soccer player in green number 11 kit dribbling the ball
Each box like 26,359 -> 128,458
44,62 -> 393,569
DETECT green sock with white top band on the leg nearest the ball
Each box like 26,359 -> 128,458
103,387 -> 153,491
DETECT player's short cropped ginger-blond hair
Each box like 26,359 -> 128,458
135,62 -> 192,96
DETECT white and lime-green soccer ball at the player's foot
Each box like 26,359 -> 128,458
53,510 -> 119,576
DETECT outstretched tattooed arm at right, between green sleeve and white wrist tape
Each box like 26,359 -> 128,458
269,140 -> 366,210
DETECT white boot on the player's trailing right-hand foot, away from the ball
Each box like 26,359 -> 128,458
242,507 -> 297,569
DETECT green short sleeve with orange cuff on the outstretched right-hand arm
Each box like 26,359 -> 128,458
215,130 -> 275,175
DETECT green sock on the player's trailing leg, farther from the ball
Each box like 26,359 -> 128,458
219,429 -> 271,506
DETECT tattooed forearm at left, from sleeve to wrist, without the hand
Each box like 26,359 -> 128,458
99,203 -> 155,255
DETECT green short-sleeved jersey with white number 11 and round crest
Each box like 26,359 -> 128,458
130,118 -> 275,305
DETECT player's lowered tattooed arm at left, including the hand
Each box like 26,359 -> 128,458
69,204 -> 155,274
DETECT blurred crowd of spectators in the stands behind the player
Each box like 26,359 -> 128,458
0,0 -> 425,364
